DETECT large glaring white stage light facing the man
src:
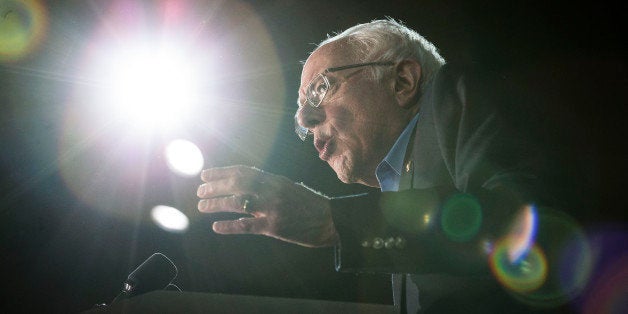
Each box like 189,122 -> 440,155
101,44 -> 198,130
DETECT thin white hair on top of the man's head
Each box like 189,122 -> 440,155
318,18 -> 445,91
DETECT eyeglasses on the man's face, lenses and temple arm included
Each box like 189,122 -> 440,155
294,61 -> 395,141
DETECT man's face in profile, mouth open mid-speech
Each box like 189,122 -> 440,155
297,42 -> 403,187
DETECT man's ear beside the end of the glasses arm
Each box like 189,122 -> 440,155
394,59 -> 421,109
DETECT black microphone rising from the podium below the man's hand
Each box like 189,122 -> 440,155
111,253 -> 181,303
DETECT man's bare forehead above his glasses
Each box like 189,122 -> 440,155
301,40 -> 356,88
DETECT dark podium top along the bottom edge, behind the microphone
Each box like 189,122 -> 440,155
83,290 -> 394,314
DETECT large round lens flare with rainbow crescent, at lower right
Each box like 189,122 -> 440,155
489,206 -> 593,308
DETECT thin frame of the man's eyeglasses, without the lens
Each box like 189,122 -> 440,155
294,61 -> 395,141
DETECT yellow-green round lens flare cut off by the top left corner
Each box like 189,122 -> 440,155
0,0 -> 48,62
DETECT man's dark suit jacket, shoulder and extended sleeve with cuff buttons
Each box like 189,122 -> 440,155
332,65 -> 542,274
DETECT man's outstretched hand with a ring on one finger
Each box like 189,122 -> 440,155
197,166 -> 338,247
